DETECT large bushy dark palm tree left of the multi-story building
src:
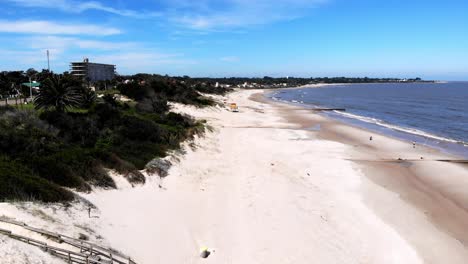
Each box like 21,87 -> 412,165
34,76 -> 83,112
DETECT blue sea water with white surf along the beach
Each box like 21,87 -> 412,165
269,82 -> 468,158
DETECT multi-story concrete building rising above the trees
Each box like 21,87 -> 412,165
70,58 -> 115,82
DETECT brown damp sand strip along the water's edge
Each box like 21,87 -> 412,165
253,90 -> 468,263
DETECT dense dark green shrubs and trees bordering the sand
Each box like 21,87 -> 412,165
0,72 -> 225,202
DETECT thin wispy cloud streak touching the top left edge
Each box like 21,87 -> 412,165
7,0 -> 161,18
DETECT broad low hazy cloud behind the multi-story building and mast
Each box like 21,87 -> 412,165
0,32 -> 196,74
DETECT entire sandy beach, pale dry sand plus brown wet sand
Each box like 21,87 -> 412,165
0,90 -> 468,264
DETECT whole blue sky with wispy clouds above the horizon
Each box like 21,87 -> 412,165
0,0 -> 468,80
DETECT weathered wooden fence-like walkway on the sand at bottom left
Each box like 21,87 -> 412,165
0,217 -> 136,264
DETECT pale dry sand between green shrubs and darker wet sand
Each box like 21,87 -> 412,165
0,88 -> 464,264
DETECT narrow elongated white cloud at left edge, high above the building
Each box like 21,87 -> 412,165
0,20 -> 121,36
